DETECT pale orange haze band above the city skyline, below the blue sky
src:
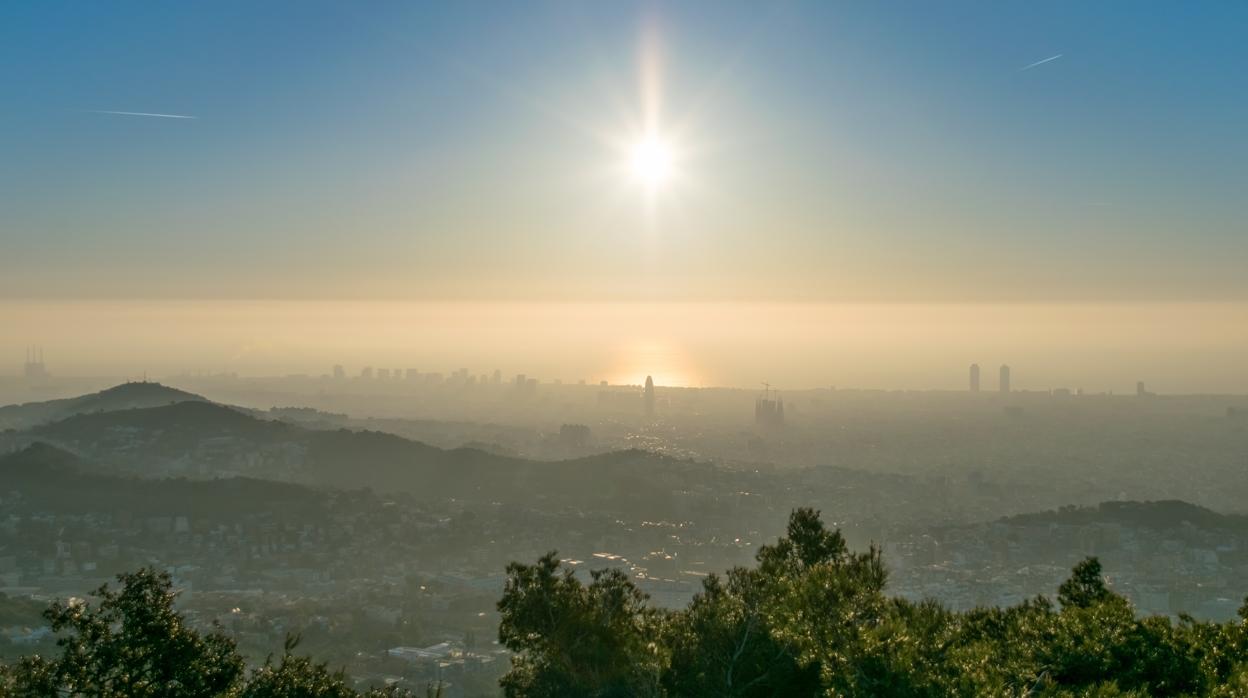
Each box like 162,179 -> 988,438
9,295 -> 1248,393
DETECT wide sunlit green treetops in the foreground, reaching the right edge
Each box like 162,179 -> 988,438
499,509 -> 1248,697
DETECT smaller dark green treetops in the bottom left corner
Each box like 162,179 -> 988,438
0,569 -> 411,698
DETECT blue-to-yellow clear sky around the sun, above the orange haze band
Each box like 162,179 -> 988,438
0,1 -> 1248,382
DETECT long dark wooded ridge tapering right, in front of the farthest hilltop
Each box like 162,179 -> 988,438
27,402 -> 748,512
